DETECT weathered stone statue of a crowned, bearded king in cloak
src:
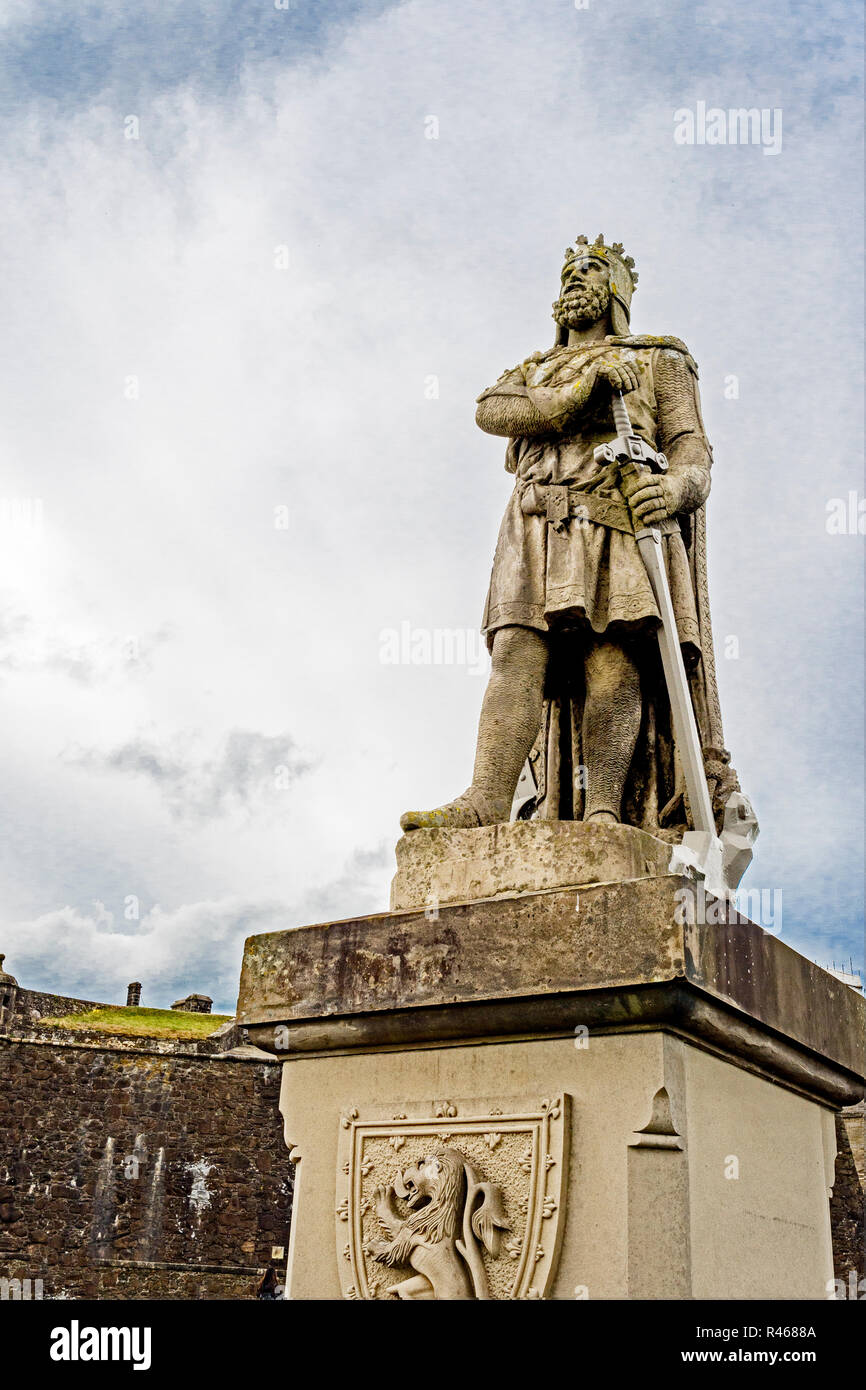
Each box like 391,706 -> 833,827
400,235 -> 752,840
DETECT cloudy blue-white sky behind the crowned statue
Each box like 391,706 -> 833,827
0,0 -> 865,1012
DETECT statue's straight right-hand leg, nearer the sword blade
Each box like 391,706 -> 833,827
581,638 -> 641,821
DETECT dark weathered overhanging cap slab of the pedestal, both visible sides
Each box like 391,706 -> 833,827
238,876 -> 866,1105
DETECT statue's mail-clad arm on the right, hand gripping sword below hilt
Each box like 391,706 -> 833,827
623,348 -> 713,525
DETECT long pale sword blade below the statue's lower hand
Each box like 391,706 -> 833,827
635,527 -> 716,838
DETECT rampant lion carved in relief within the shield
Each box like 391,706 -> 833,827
367,1148 -> 510,1300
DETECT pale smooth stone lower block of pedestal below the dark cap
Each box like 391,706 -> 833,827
281,1023 -> 835,1300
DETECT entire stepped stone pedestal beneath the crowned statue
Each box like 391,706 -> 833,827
238,824 -> 865,1300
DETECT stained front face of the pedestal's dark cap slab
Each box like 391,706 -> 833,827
238,878 -> 684,1026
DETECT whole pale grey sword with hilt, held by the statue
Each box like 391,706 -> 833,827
594,391 -> 724,897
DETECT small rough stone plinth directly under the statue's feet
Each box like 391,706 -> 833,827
391,820 -> 671,912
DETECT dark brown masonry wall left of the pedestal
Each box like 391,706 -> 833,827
0,1029 -> 292,1300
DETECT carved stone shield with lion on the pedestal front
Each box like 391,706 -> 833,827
336,1095 -> 570,1301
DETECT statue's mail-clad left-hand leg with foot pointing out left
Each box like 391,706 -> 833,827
400,627 -> 548,830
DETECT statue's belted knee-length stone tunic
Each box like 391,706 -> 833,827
478,339 -> 709,659
